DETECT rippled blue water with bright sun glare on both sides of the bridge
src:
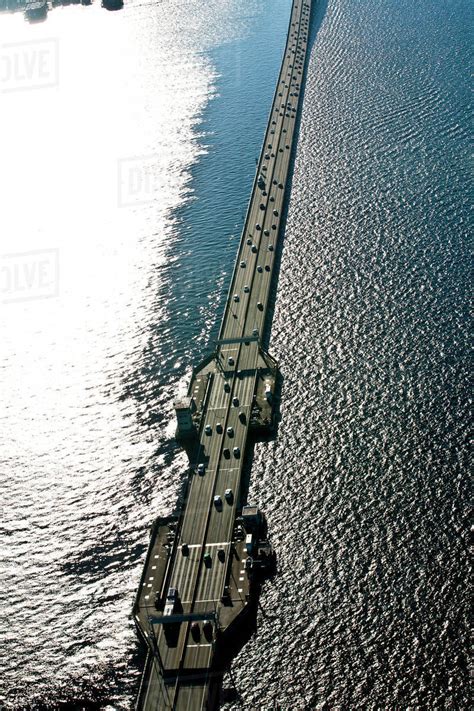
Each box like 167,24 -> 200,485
0,0 -> 472,709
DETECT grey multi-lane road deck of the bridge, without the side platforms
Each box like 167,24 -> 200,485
140,0 -> 311,709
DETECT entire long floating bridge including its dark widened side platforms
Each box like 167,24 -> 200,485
133,0 -> 312,711
